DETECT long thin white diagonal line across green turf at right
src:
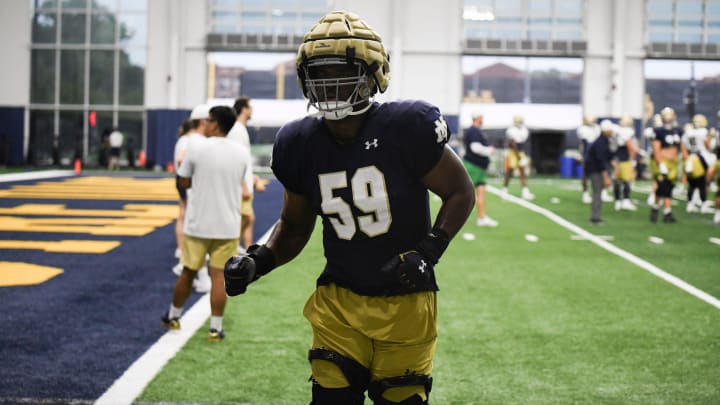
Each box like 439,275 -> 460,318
486,184 -> 720,309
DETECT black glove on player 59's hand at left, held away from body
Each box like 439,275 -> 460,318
225,245 -> 275,297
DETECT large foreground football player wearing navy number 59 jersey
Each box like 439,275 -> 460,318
225,11 -> 475,405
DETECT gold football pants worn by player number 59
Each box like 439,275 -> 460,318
303,284 -> 437,402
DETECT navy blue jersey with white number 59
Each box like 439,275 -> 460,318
271,101 -> 448,295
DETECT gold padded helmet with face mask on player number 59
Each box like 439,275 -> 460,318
295,11 -> 390,120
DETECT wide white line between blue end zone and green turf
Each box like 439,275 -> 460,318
95,225 -> 275,405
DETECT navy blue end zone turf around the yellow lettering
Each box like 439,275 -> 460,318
0,172 -> 282,404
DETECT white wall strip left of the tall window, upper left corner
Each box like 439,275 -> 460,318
0,0 -> 32,106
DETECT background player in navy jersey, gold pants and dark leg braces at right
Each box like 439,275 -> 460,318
650,107 -> 683,223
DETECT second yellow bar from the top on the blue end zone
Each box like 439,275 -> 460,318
0,204 -> 178,218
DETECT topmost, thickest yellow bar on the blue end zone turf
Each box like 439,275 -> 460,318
0,176 -> 178,201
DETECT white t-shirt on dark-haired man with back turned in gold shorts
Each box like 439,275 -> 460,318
178,137 -> 250,239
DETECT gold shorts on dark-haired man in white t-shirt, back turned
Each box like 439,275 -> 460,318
180,234 -> 240,271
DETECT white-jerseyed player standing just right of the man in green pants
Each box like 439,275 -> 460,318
502,115 -> 535,200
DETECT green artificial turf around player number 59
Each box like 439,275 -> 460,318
138,179 -> 720,404
